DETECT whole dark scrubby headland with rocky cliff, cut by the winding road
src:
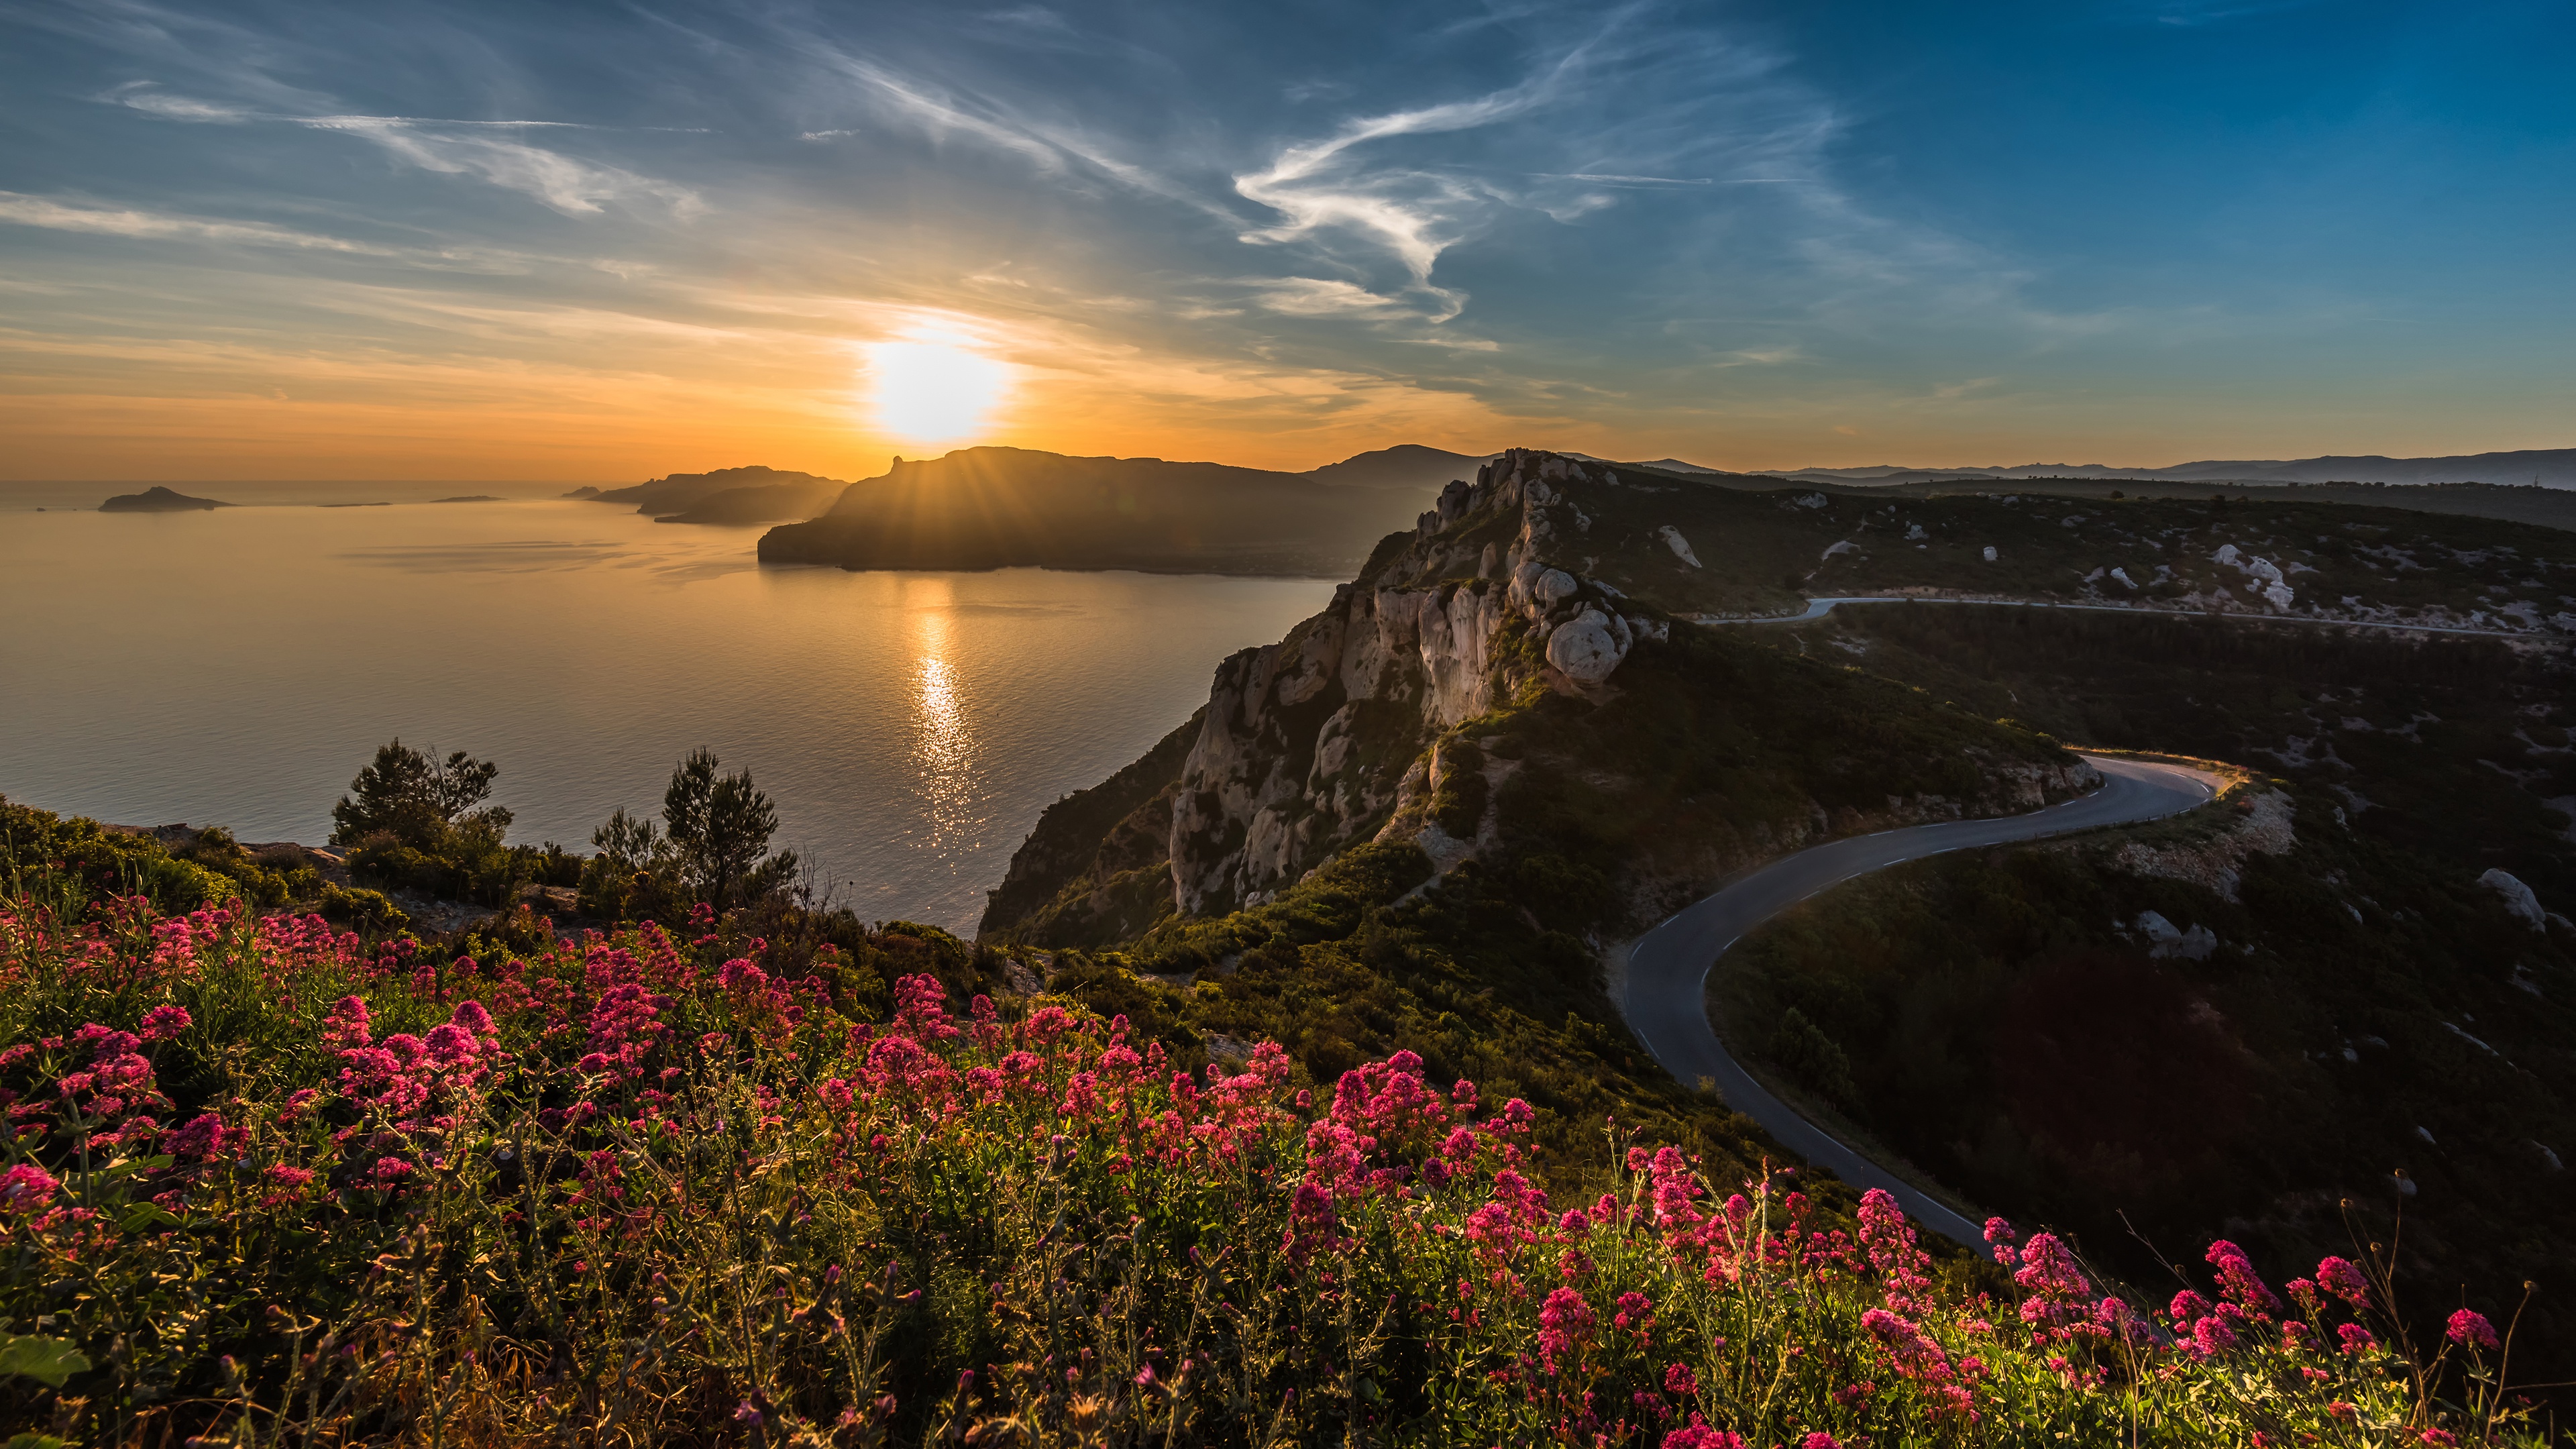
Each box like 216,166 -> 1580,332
984,453 -> 2576,1366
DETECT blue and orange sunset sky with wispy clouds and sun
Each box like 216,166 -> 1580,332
0,0 -> 2576,482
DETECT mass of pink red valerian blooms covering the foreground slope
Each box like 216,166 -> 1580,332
0,902 -> 2534,1449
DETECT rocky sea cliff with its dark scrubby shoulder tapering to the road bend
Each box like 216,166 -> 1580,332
984,451 -> 2089,944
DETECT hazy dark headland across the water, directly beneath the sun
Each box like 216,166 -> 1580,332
760,449 -> 1448,575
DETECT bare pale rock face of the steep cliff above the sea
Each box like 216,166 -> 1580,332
1172,449 -> 1669,913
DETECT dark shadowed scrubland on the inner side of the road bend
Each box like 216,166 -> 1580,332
1718,608 -> 2576,1379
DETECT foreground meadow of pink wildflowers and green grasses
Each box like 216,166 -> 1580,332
0,895 -> 2545,1449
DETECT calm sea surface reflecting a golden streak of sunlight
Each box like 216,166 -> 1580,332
0,485 -> 1332,930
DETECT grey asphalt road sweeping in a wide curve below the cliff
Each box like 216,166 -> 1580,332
1618,755 -> 2223,1245
